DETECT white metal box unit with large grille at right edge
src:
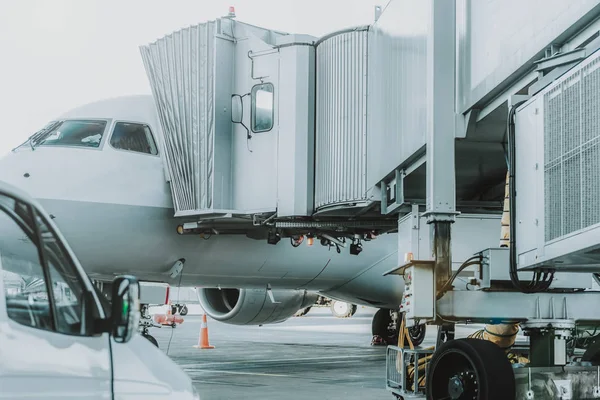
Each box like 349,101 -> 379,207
516,47 -> 600,270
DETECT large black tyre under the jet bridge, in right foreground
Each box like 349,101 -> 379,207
426,338 -> 516,400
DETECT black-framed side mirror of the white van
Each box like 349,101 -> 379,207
111,276 -> 140,343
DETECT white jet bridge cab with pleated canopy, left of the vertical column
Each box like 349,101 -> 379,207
141,1 -> 460,228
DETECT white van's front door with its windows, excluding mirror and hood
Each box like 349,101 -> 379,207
0,193 -> 111,399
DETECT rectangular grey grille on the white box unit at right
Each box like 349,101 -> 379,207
544,52 -> 600,241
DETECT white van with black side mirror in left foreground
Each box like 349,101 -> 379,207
0,182 -> 200,400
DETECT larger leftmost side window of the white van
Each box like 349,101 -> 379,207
0,195 -> 53,330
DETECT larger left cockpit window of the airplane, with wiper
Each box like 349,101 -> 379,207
34,120 -> 106,147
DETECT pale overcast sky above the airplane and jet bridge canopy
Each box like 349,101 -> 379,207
0,0 -> 388,156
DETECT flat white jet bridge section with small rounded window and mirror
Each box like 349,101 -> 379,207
230,38 -> 280,210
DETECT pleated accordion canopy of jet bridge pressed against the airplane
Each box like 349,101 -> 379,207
141,19 -> 290,215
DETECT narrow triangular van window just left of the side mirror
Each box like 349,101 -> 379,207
37,216 -> 98,335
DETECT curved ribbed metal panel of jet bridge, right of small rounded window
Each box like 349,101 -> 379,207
315,28 -> 368,209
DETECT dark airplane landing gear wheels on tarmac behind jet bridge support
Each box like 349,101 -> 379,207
371,308 -> 427,346
